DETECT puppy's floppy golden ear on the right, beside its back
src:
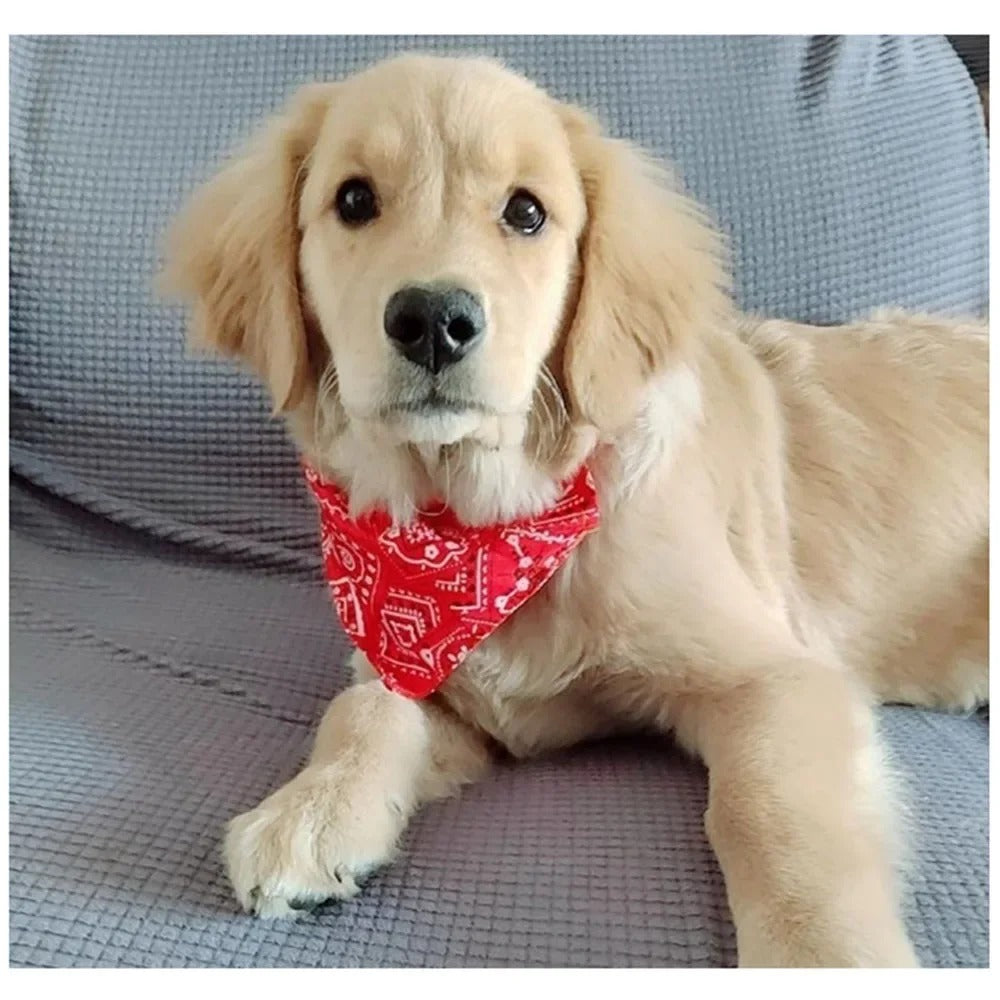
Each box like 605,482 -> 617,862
559,105 -> 728,433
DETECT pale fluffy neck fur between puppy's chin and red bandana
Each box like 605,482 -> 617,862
291,365 -> 702,525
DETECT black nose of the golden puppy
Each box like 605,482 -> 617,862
385,285 -> 486,375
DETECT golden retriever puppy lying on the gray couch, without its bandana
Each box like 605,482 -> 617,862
166,56 -> 988,966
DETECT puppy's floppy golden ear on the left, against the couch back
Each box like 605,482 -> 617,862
161,84 -> 336,413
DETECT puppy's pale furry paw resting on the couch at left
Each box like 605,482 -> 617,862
223,765 -> 404,919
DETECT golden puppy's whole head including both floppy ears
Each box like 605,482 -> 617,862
167,56 -> 724,509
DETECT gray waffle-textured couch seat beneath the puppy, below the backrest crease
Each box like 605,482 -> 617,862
10,487 -> 988,966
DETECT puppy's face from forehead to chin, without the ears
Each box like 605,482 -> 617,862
298,54 -> 586,444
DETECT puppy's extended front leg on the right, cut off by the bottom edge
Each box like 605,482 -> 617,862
675,660 -> 916,967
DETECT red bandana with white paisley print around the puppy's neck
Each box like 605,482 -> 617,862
305,466 -> 600,698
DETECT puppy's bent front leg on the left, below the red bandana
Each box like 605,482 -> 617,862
223,657 -> 489,917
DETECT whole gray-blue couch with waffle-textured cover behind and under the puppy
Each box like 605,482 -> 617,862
10,37 -> 988,966
